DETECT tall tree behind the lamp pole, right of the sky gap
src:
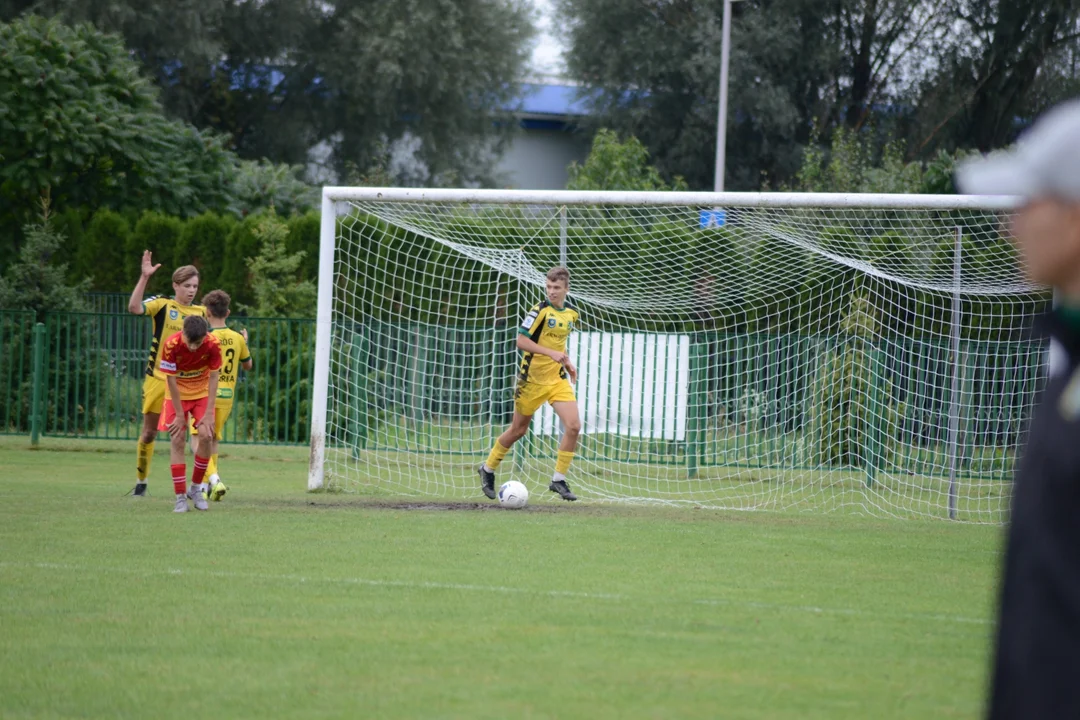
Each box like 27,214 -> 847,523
558,0 -> 851,189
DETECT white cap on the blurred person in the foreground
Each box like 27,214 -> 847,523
956,99 -> 1080,202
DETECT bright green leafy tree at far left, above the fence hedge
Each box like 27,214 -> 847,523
0,15 -> 235,264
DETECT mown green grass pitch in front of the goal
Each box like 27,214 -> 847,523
0,438 -> 1000,719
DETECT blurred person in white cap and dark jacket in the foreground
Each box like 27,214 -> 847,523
957,100 -> 1080,720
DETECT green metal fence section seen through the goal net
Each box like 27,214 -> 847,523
328,324 -> 1045,480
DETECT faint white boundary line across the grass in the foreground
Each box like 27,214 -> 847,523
0,560 -> 993,625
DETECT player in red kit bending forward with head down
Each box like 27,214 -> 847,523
160,315 -> 221,513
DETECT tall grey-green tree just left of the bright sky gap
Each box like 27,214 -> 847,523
300,0 -> 534,182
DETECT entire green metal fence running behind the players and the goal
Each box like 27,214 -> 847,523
0,312 -> 1045,479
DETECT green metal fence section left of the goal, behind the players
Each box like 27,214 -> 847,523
0,312 -> 314,445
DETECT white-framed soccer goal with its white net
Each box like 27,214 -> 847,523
309,188 -> 1036,521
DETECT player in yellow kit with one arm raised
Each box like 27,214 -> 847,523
127,250 -> 204,498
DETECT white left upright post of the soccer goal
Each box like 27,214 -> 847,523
308,188 -> 337,490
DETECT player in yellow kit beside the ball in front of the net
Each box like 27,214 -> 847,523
477,268 -> 581,500
